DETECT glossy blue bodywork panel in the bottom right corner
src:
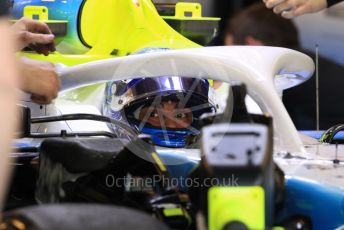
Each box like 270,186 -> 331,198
277,177 -> 344,230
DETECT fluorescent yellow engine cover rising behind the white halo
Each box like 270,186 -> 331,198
23,0 -> 200,66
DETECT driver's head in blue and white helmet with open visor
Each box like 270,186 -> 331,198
103,76 -> 217,147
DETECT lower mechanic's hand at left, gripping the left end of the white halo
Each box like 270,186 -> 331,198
19,58 -> 60,104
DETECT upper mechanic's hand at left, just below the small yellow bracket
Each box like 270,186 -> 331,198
12,18 -> 55,56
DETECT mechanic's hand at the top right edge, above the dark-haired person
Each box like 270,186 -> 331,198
263,0 -> 327,18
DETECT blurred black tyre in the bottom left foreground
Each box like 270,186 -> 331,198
0,204 -> 168,230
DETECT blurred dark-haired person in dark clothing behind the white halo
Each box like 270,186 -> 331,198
224,3 -> 344,130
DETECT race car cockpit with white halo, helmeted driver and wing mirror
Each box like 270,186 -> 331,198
5,47 -> 343,229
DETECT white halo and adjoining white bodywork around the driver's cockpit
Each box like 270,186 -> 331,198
21,46 -> 344,187
